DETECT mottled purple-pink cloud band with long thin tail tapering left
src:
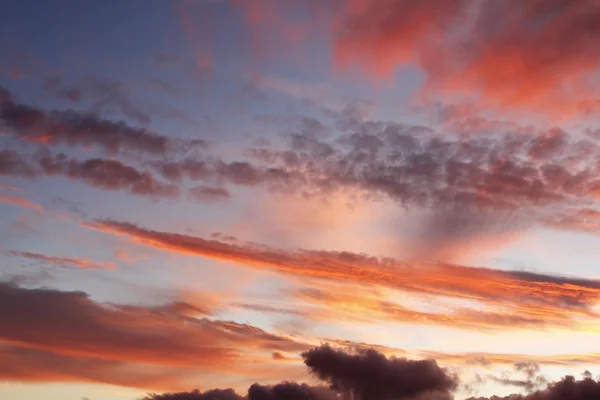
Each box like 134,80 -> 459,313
145,117 -> 600,222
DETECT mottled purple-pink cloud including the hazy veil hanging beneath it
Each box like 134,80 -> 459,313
234,118 -> 600,255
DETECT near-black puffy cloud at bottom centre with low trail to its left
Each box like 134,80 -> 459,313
144,346 -> 457,400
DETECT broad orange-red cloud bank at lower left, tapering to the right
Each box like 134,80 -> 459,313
0,283 -> 307,388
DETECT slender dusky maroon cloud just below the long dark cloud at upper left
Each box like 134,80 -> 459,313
39,153 -> 180,198
